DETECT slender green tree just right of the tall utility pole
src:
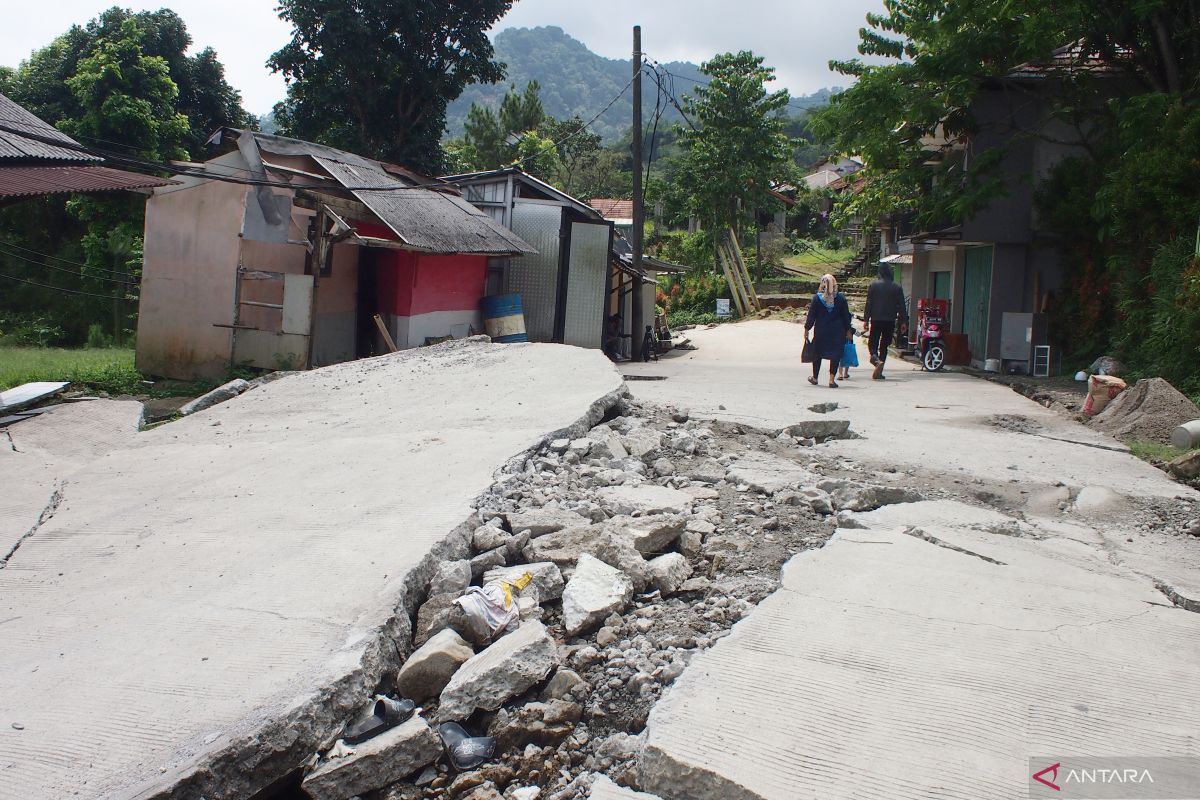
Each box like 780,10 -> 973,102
678,52 -> 792,237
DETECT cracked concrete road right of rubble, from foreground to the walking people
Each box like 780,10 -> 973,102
623,321 -> 1200,800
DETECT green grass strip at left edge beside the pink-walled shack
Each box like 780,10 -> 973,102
0,347 -> 149,395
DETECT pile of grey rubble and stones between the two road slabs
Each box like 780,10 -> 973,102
297,403 -> 922,800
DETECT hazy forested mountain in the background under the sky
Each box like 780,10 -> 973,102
446,26 -> 839,142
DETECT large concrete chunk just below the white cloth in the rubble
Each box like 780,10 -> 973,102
437,620 -> 558,722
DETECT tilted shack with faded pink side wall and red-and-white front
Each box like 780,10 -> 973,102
137,128 -> 534,379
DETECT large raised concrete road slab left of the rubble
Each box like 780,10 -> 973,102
0,343 -> 620,800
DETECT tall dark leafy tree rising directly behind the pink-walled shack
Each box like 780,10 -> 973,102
268,0 -> 512,173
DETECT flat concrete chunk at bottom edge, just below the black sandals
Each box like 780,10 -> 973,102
302,716 -> 442,800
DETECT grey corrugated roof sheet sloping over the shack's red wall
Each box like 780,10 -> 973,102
314,155 -> 536,255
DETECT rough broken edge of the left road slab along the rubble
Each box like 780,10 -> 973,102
118,384 -> 629,800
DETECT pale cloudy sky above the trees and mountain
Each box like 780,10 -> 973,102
0,0 -> 883,114
